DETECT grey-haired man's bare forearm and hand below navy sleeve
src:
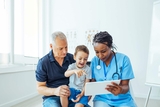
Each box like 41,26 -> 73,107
37,82 -> 70,97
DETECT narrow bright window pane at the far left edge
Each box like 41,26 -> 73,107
0,0 -> 10,64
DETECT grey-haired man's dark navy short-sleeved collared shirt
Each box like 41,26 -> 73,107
36,50 -> 75,99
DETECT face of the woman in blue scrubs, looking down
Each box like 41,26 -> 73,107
93,43 -> 111,62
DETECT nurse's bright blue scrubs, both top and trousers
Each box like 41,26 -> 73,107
91,53 -> 134,106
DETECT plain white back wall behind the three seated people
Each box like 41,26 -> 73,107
46,0 -> 160,98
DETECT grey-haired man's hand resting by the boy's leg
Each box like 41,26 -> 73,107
54,85 -> 70,97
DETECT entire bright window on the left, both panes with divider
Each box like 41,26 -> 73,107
0,0 -> 39,65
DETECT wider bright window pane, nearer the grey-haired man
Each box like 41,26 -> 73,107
14,0 -> 39,64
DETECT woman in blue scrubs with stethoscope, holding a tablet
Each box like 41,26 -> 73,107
90,31 -> 137,107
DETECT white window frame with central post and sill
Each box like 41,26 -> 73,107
0,0 -> 42,68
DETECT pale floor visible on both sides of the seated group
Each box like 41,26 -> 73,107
12,95 -> 160,107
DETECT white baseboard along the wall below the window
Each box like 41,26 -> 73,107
0,93 -> 38,107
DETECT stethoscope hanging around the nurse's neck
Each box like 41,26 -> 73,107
96,51 -> 120,79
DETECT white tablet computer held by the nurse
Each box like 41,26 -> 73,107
85,80 -> 120,96
